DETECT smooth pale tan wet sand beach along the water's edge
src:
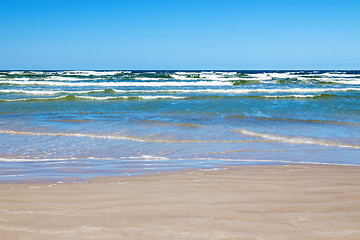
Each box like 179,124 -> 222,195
0,165 -> 360,240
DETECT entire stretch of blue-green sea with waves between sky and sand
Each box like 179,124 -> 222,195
0,71 -> 360,182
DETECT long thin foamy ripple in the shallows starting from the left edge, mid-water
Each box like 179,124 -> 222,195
0,129 -> 275,143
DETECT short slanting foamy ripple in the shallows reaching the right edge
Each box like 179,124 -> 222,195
235,129 -> 360,149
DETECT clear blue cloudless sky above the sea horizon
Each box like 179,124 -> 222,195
0,0 -> 360,70
